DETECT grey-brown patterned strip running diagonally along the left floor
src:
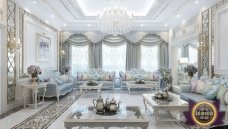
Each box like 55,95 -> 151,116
12,91 -> 80,129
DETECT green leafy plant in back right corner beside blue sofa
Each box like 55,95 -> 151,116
159,68 -> 173,85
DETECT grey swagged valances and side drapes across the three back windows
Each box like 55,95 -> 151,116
63,34 -> 168,70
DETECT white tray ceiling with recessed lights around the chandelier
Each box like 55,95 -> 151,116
15,0 -> 217,31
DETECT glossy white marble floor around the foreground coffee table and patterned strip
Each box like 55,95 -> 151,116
0,90 -> 187,129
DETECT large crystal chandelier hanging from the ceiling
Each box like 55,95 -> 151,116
98,6 -> 134,35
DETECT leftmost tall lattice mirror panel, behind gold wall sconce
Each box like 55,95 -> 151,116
7,0 -> 16,103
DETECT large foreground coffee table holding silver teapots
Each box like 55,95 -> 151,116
64,106 -> 149,129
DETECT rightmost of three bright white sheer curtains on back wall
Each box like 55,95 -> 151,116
141,45 -> 159,72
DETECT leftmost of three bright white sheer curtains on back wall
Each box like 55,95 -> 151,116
71,45 -> 89,76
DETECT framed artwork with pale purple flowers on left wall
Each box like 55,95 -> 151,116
36,33 -> 51,62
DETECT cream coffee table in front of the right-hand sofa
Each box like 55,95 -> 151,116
142,92 -> 189,122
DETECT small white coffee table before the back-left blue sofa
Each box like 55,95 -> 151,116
79,82 -> 103,96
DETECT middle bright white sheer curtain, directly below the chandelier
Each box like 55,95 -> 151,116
102,43 -> 126,71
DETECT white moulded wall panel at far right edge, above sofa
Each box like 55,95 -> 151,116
212,1 -> 228,74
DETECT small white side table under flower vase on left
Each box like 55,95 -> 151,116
21,83 -> 47,108
